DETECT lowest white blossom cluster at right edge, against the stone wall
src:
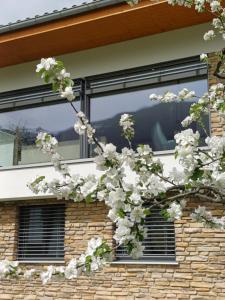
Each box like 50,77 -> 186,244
191,206 -> 225,229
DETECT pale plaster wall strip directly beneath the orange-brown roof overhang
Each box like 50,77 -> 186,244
0,24 -> 224,92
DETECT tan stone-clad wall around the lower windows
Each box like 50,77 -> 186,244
0,54 -> 225,300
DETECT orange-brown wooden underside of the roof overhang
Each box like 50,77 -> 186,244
0,0 -> 212,67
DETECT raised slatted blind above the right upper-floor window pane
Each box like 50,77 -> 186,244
86,57 -> 208,95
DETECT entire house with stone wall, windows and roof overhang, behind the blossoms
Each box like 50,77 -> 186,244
0,0 -> 225,300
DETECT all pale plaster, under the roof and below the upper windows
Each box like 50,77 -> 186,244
0,24 -> 224,200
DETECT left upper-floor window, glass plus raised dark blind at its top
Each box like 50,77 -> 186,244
0,82 -> 81,167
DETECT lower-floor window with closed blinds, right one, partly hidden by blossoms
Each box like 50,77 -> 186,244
116,209 -> 176,262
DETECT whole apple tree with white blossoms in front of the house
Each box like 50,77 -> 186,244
0,0 -> 225,284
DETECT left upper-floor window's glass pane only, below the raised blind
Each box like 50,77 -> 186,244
0,101 -> 80,167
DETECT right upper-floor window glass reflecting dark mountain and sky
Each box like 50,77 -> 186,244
91,79 -> 209,151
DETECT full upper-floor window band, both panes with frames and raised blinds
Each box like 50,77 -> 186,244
0,57 -> 209,167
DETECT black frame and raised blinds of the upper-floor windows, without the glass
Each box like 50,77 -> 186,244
0,56 -> 211,167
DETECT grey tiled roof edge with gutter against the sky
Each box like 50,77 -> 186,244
0,0 -> 125,34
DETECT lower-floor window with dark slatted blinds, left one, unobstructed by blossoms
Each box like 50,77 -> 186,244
17,204 -> 65,261
